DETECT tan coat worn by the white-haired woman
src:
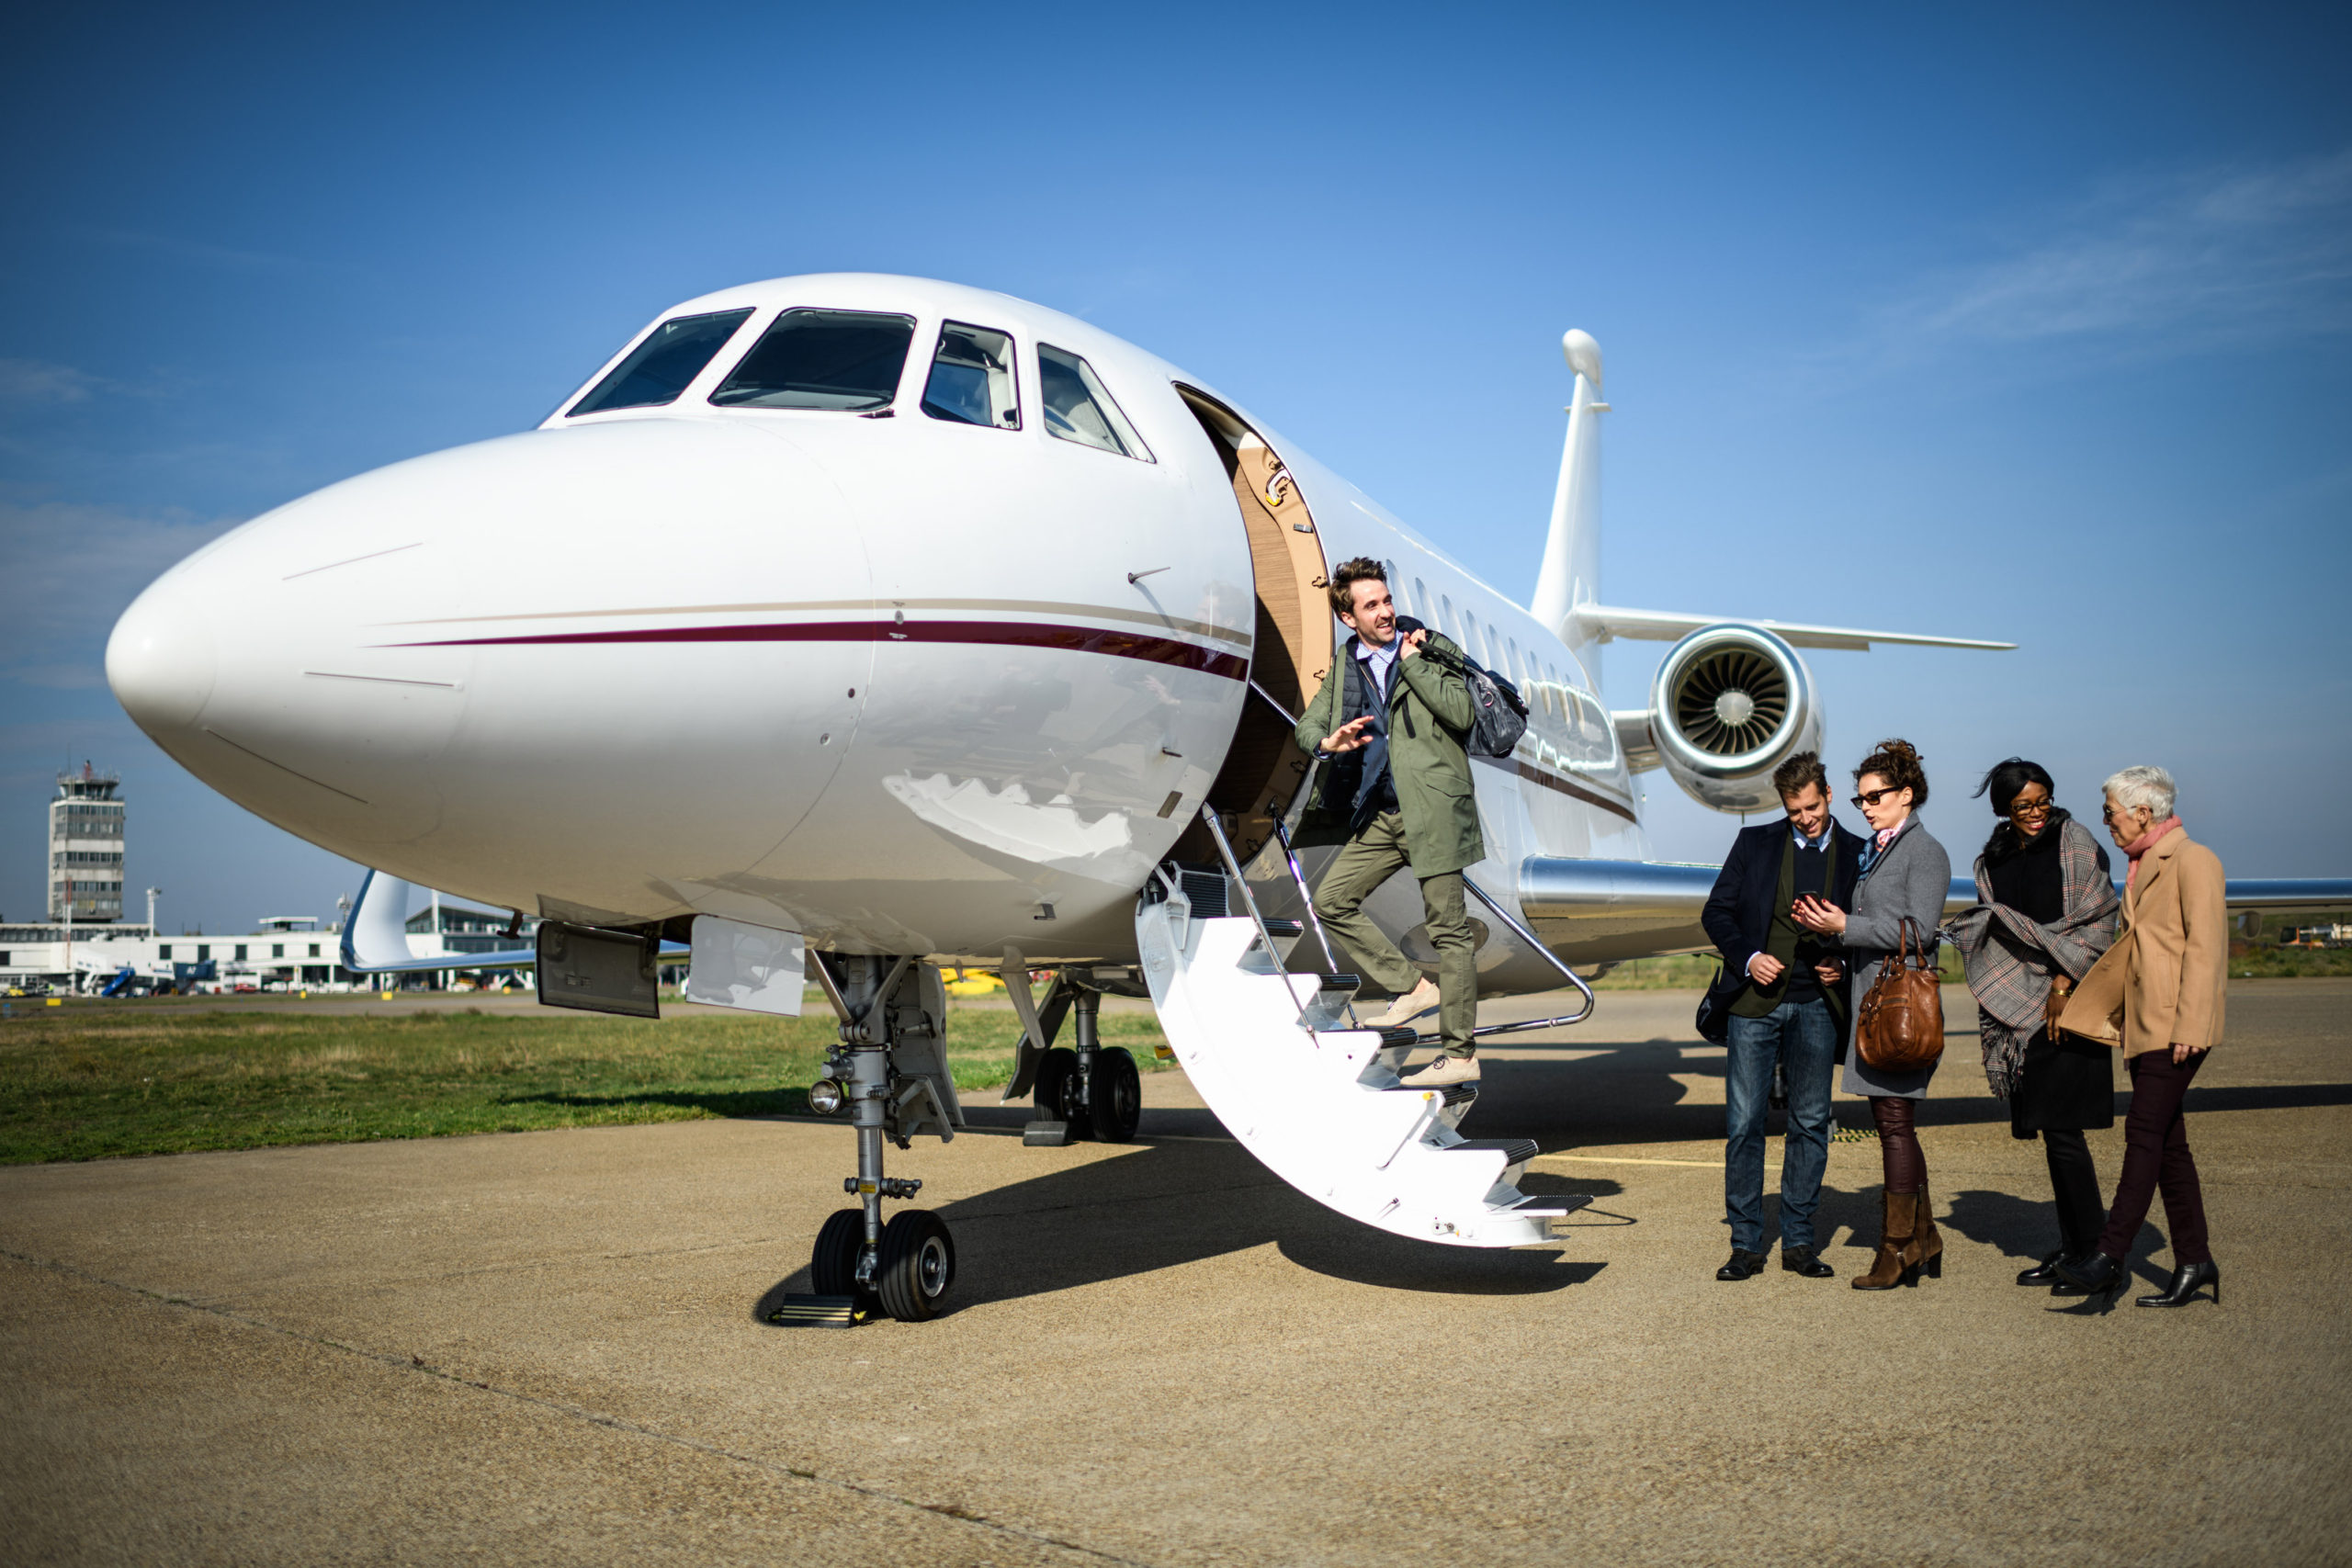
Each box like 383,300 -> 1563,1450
2058,829 -> 2230,1058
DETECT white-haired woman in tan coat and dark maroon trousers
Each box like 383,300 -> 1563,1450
2055,766 -> 2230,1307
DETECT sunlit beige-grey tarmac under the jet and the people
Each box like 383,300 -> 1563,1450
0,980 -> 2352,1565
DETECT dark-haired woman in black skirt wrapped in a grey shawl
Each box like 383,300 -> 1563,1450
1952,757 -> 2121,1295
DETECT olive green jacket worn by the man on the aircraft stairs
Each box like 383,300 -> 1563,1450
1296,632 -> 1487,877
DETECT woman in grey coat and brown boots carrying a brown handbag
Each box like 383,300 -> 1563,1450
1790,740 -> 1952,1291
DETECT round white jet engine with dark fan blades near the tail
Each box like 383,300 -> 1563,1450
1649,621 -> 1820,811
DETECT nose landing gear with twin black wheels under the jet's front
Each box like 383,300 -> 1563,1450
772,952 -> 965,1328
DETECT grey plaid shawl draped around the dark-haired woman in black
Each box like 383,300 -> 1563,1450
1945,816 -> 2121,1100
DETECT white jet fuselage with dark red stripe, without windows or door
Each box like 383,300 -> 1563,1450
108,275 -> 1646,962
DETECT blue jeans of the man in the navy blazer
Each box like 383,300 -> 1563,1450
1724,997 -> 1839,1253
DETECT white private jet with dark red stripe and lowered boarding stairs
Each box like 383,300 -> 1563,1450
106,273 -> 2347,1324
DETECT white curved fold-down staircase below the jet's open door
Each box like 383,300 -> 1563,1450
1136,818 -> 1590,1246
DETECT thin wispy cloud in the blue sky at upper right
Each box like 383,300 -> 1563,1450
1874,151 -> 2352,355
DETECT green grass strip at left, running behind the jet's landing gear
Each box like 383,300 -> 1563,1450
0,1004 -> 1162,1164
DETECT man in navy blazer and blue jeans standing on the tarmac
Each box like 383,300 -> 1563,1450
1698,752 -> 1863,1279
